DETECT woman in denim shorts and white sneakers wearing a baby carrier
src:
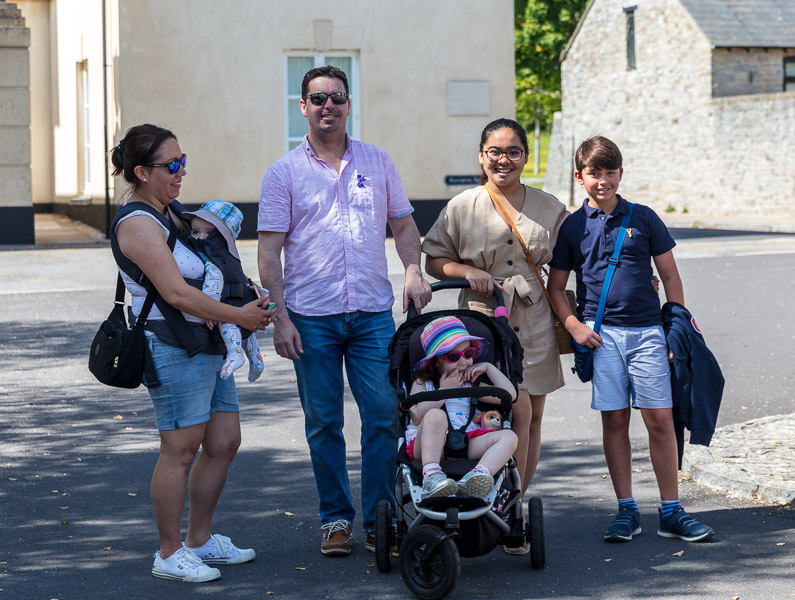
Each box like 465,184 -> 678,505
110,125 -> 275,583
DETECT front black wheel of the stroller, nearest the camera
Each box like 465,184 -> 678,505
400,525 -> 461,600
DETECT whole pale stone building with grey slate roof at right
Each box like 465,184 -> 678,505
544,0 -> 795,216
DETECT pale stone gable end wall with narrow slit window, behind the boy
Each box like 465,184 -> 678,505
544,0 -> 712,208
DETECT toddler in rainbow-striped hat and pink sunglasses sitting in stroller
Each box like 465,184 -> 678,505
406,317 -> 517,498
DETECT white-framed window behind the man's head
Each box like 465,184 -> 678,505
284,52 -> 359,152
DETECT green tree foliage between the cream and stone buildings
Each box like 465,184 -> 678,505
514,0 -> 589,128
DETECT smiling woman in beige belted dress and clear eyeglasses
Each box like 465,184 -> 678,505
422,119 -> 568,532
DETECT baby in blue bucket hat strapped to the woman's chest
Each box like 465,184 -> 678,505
182,200 -> 265,381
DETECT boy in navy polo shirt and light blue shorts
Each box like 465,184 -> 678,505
547,136 -> 715,542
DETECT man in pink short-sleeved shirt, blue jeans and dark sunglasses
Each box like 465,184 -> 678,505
257,65 -> 431,556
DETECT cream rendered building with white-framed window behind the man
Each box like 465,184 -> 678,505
0,0 -> 515,243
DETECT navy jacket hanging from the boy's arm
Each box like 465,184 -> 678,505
662,302 -> 725,468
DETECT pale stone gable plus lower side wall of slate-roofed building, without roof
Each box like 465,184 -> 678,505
544,0 -> 795,220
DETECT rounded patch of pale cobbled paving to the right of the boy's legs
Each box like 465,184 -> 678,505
682,414 -> 795,506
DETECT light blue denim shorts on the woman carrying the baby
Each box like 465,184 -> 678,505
147,335 -> 240,430
